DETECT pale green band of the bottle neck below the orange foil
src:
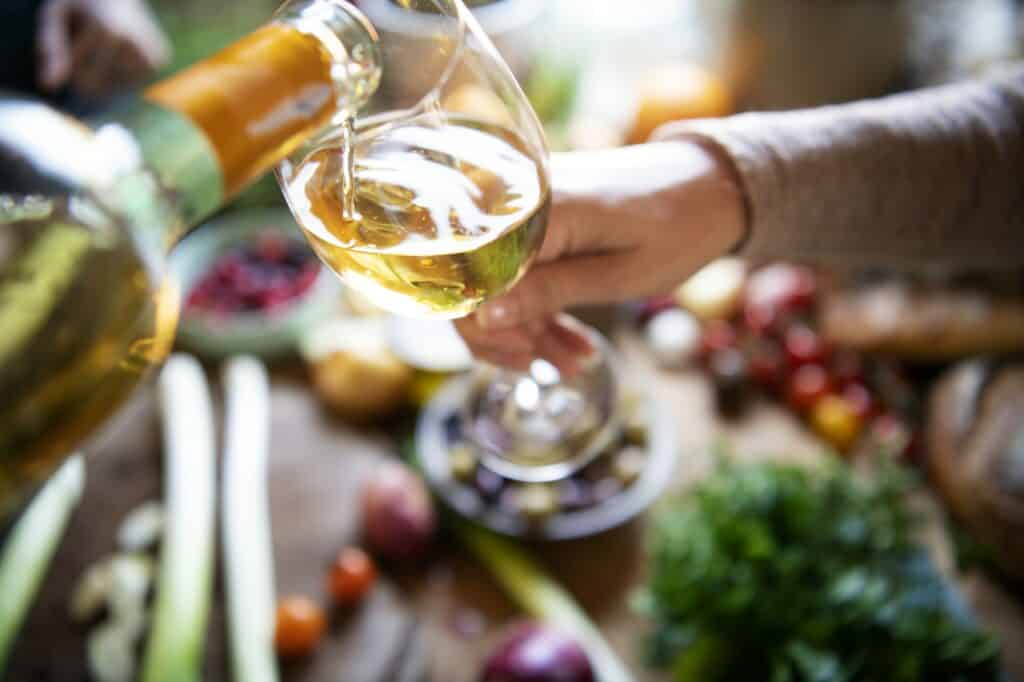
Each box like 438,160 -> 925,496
103,99 -> 224,229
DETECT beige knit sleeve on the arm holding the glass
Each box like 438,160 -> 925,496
656,68 -> 1024,269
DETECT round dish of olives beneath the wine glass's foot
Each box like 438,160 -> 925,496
407,376 -> 680,540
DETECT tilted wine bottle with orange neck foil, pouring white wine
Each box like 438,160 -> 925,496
0,0 -> 381,519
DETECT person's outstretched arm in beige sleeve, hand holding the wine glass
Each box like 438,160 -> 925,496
460,70 -> 1024,367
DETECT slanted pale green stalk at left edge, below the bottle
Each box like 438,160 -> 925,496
0,455 -> 85,667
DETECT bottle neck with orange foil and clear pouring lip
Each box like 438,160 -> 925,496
103,0 -> 379,246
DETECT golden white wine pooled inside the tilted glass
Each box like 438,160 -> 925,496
285,112 -> 550,317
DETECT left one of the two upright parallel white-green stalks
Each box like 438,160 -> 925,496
141,355 -> 216,682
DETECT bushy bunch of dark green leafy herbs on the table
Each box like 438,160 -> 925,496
639,454 -> 999,682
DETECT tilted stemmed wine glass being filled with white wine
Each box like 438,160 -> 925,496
278,0 -> 617,481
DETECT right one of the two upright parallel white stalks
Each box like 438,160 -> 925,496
221,357 -> 278,682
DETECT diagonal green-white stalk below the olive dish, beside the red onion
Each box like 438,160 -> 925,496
453,520 -> 633,682
